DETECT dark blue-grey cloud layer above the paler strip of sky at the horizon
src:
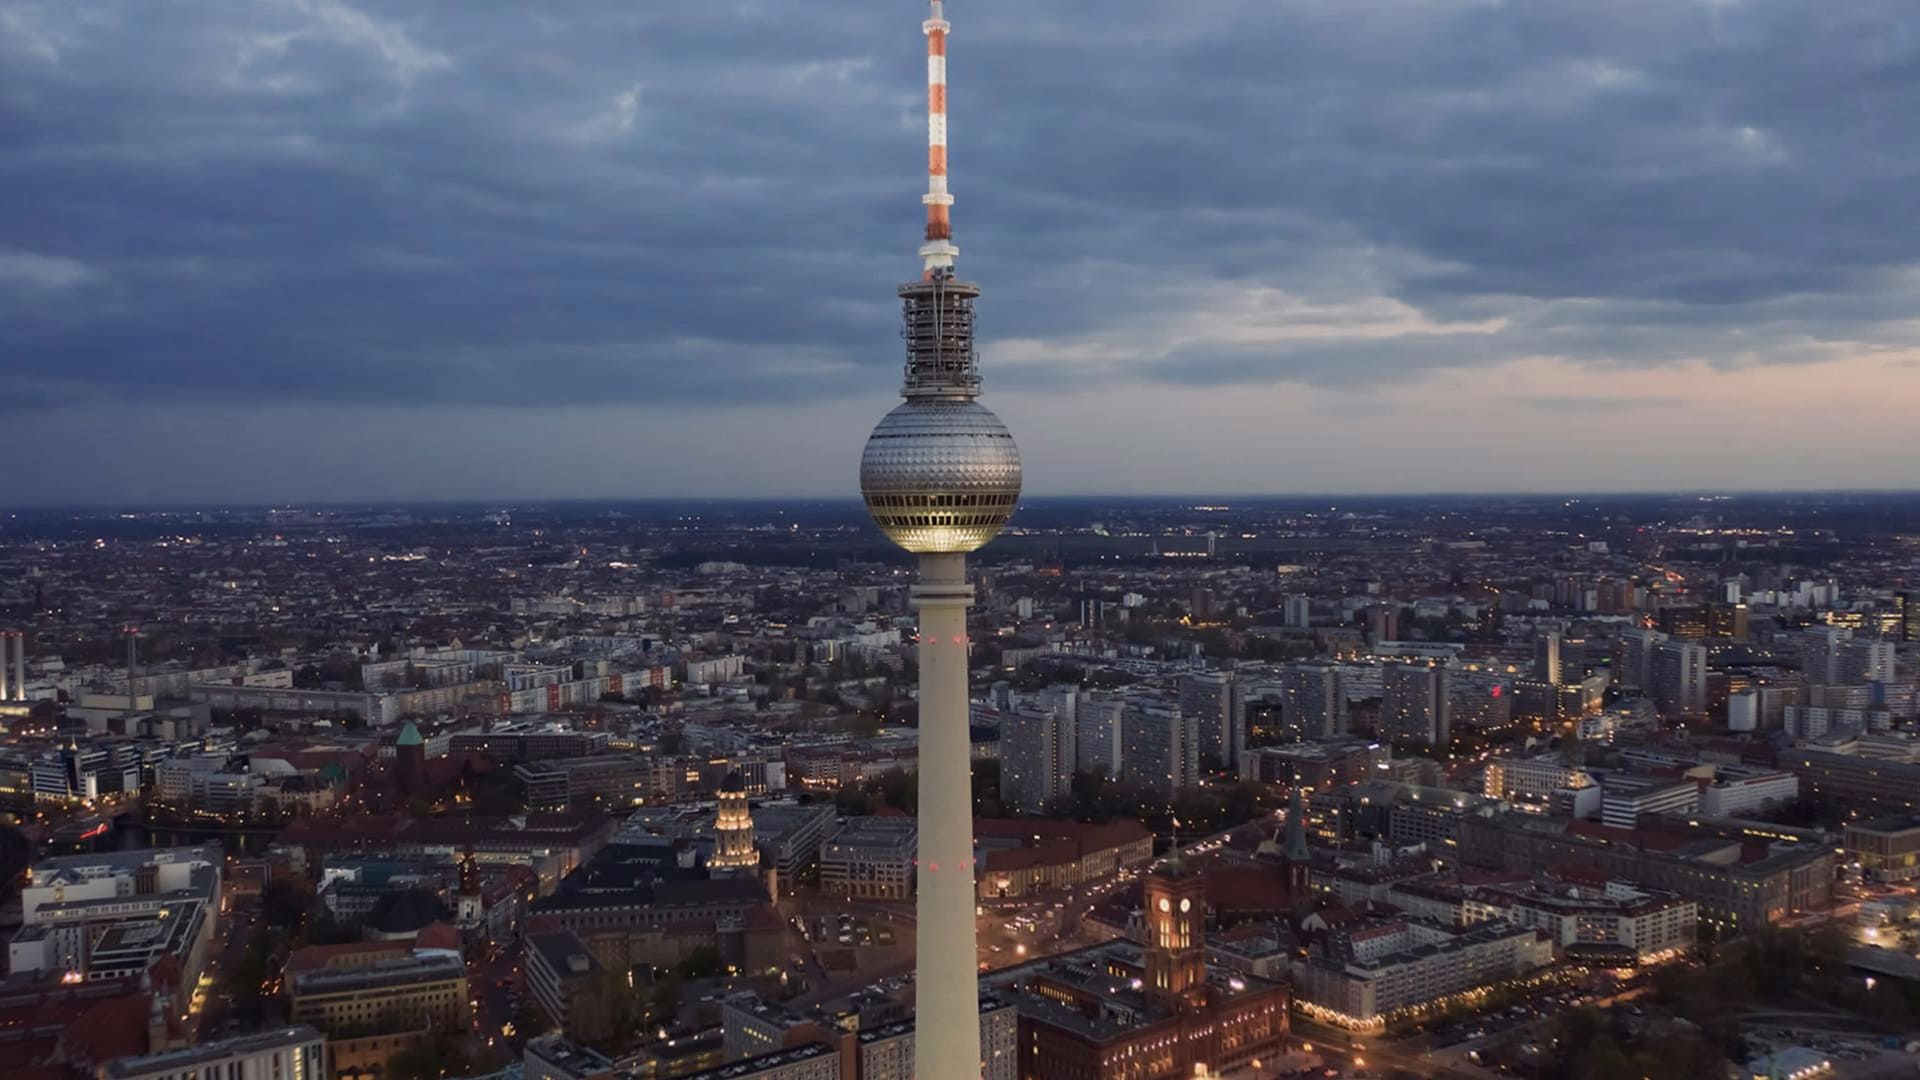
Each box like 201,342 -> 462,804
0,0 -> 1920,407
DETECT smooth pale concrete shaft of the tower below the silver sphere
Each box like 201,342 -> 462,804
912,553 -> 981,1080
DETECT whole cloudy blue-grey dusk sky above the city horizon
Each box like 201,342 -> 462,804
0,0 -> 1920,503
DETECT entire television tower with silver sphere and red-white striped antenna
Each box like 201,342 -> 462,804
860,0 -> 1020,1080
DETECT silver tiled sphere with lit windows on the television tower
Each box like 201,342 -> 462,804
860,398 -> 1020,555
